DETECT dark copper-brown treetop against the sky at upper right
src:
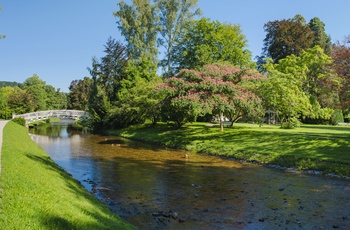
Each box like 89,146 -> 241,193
259,15 -> 315,65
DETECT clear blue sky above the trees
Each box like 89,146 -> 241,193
0,0 -> 350,92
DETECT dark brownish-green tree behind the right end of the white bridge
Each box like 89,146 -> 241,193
68,77 -> 92,111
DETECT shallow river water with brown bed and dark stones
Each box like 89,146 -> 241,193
30,123 -> 350,229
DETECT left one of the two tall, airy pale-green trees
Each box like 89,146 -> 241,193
113,0 -> 158,68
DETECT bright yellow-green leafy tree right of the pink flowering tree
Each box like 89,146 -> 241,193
260,46 -> 341,123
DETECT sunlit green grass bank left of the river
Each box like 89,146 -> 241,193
0,122 -> 132,230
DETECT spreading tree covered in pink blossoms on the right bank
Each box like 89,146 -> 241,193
159,63 -> 263,131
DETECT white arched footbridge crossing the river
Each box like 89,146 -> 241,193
12,110 -> 88,124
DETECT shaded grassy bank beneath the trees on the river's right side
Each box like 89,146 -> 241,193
108,123 -> 350,176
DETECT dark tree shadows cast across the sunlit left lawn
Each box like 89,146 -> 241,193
26,154 -> 130,230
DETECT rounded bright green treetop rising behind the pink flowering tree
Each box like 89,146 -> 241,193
174,18 -> 254,72
